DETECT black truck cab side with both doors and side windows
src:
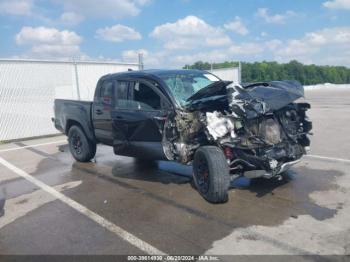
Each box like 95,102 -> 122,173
92,70 -> 174,159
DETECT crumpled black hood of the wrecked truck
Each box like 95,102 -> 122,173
186,80 -> 304,118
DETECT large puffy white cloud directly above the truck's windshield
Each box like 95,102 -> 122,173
150,16 -> 231,49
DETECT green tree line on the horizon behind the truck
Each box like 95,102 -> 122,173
183,60 -> 350,85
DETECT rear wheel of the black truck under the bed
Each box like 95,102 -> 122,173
68,126 -> 96,162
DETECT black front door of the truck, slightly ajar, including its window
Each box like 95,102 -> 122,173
112,79 -> 170,159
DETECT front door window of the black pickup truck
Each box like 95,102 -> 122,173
132,82 -> 161,110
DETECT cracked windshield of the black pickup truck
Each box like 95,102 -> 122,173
159,71 -> 220,106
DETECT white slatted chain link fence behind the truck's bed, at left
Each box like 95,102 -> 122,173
0,60 -> 139,141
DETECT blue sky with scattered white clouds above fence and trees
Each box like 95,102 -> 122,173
0,0 -> 350,68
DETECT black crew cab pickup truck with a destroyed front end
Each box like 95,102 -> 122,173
53,70 -> 312,203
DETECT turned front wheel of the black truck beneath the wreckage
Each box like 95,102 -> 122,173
193,146 -> 230,203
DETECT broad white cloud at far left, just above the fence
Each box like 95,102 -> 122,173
16,27 -> 82,59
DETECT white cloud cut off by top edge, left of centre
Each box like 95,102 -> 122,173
63,0 -> 149,19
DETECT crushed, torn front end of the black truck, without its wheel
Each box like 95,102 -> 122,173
163,81 -> 312,178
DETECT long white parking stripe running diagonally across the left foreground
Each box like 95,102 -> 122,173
0,157 -> 165,255
